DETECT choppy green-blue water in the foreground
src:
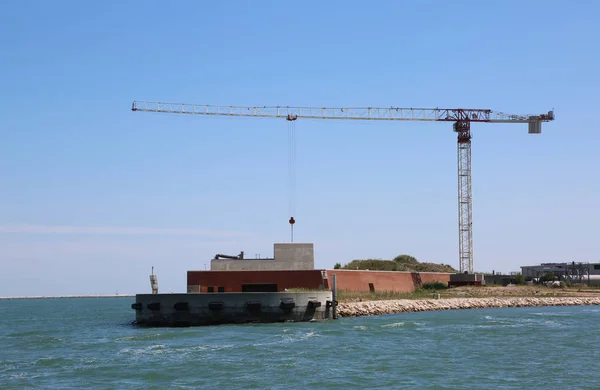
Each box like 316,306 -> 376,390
0,298 -> 600,389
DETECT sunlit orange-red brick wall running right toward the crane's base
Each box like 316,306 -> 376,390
327,269 -> 450,292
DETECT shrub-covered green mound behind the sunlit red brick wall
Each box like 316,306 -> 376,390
335,255 -> 458,273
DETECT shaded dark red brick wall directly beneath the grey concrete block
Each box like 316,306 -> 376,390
187,270 -> 323,292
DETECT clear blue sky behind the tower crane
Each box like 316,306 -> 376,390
0,0 -> 600,296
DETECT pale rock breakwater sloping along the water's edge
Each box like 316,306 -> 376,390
337,297 -> 600,317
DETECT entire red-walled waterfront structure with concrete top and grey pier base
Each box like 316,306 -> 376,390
136,243 -> 450,326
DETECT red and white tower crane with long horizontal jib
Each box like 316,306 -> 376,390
131,101 -> 554,273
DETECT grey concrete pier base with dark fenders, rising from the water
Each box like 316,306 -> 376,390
131,291 -> 334,327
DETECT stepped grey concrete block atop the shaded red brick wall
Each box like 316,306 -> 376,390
210,243 -> 315,271
